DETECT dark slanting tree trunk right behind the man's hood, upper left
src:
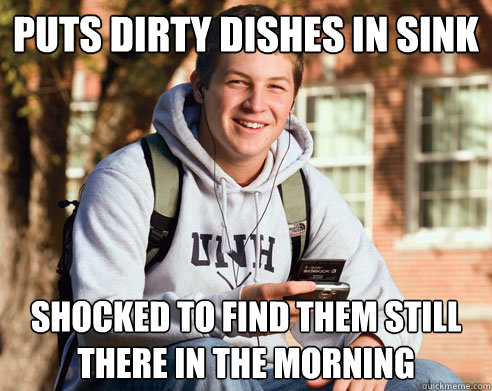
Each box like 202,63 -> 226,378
85,0 -> 223,173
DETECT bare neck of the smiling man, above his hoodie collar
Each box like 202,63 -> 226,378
198,115 -> 266,183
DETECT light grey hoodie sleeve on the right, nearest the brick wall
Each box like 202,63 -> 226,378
292,165 -> 422,355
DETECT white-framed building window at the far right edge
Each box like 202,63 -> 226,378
407,74 -> 492,247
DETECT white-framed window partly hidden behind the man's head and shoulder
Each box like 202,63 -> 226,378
296,83 -> 373,231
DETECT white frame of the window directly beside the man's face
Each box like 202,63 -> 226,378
295,80 -> 374,237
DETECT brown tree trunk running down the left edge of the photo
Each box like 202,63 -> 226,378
0,0 -> 79,389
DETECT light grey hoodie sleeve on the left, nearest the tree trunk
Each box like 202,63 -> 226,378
70,151 -> 244,347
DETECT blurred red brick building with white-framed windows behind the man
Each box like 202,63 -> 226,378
71,0 -> 492,383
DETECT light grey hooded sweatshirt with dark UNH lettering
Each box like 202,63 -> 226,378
56,84 -> 421,389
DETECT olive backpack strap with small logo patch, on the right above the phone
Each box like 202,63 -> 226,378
278,169 -> 311,277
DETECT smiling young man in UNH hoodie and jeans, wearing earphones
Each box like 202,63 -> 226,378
55,6 -> 459,390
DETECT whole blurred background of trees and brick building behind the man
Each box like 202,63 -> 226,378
0,0 -> 492,390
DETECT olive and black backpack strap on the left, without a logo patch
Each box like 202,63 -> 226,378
141,133 -> 183,271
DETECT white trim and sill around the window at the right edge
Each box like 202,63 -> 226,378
396,72 -> 492,251
